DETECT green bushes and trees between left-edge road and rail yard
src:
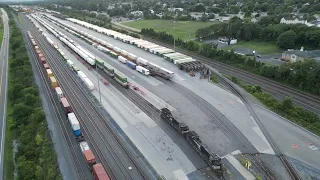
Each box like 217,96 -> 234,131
6,13 -> 62,180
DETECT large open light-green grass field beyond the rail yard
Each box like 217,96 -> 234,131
122,20 -> 214,40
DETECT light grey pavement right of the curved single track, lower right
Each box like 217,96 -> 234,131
254,105 -> 320,170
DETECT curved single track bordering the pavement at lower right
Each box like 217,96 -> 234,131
222,74 -> 301,180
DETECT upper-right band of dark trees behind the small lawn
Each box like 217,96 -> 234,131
196,17 -> 320,49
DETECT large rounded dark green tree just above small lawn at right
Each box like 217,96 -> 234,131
277,30 -> 297,49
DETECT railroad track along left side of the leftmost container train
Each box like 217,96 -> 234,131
16,17 -> 92,180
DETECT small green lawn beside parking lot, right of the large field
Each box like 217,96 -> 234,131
223,41 -> 281,54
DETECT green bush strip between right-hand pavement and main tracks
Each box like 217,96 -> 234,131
226,76 -> 320,136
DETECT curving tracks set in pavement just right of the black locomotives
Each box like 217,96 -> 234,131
158,78 -> 277,179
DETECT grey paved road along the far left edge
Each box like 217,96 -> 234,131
0,8 -> 9,179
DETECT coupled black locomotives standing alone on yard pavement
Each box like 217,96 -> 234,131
160,108 -> 223,173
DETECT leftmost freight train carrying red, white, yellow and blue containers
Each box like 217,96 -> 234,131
28,31 -> 110,180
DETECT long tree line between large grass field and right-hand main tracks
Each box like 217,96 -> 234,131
141,28 -> 320,95
